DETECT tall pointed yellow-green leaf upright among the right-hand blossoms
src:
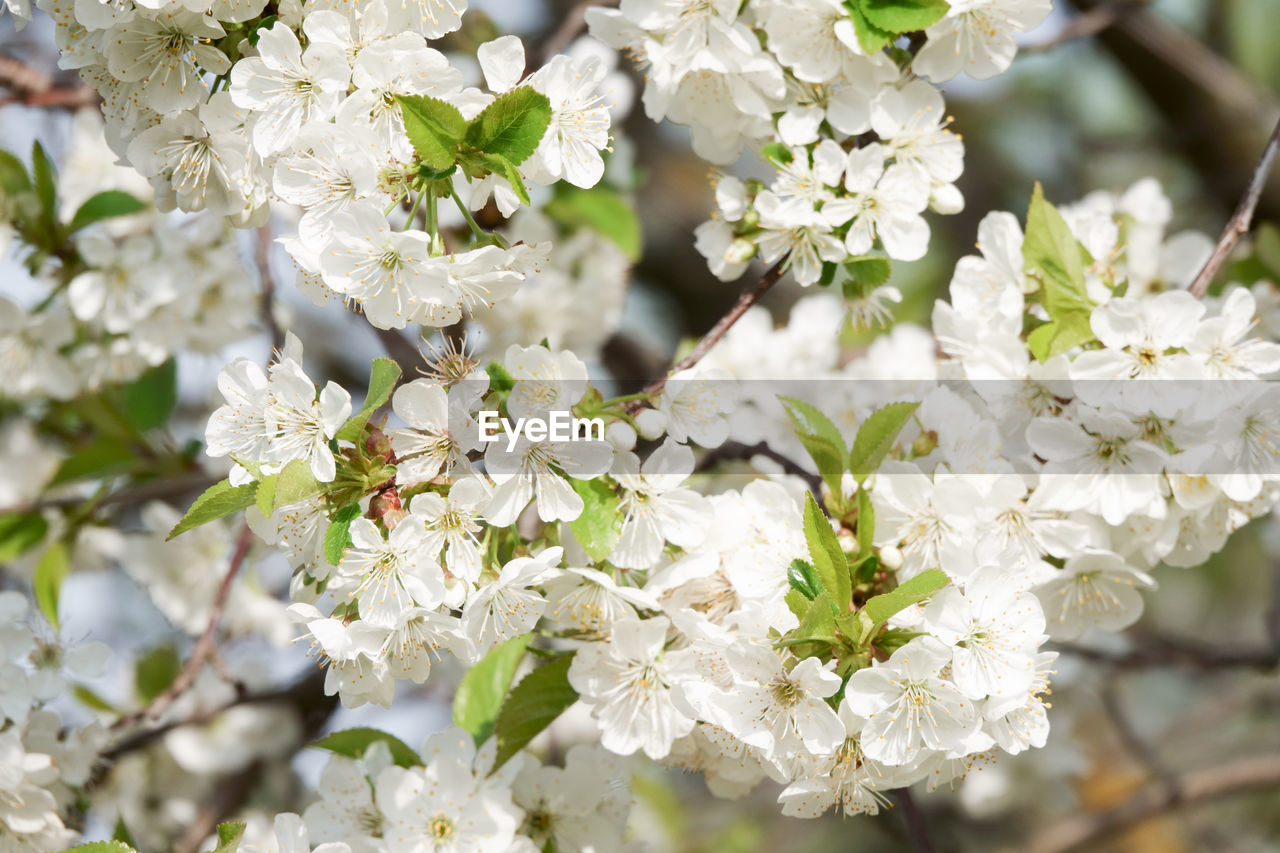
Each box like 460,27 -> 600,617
1023,183 -> 1093,320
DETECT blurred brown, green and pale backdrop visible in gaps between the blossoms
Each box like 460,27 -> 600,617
0,0 -> 1280,853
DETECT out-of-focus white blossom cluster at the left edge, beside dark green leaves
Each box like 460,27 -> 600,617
0,113 -> 256,400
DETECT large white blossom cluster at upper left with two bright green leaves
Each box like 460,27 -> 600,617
32,0 -> 622,329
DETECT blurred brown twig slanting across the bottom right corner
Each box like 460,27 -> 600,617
1025,756 -> 1280,853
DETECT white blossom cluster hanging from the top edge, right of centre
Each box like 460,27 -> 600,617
588,0 -> 1050,286
